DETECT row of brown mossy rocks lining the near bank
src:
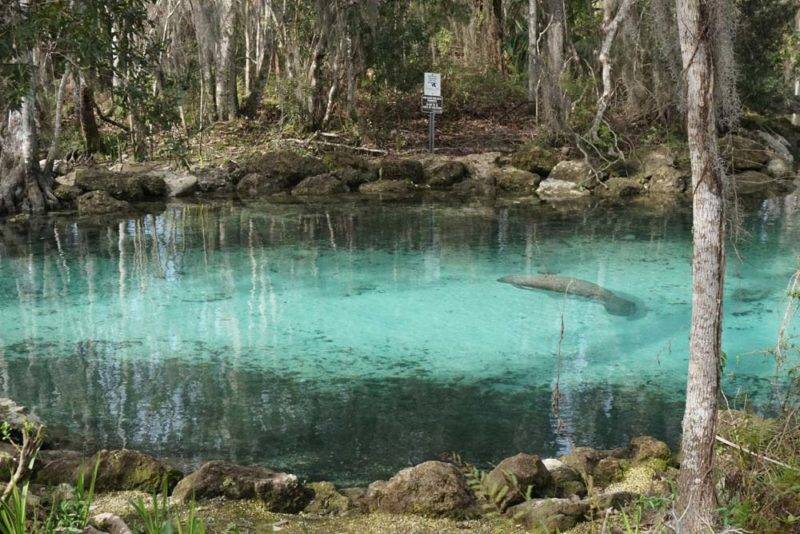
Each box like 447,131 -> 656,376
0,399 -> 676,532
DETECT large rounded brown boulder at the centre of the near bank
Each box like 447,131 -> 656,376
368,461 -> 475,518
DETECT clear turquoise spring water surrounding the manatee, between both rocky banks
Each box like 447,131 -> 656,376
0,197 -> 800,483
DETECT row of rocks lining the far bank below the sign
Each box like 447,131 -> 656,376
17,126 -> 797,222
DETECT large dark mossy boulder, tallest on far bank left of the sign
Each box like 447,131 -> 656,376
236,150 -> 327,197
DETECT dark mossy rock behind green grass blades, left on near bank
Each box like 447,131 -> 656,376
86,449 -> 183,493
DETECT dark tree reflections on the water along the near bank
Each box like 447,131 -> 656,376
2,341 -> 680,482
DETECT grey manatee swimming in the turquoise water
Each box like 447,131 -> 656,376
498,274 -> 636,317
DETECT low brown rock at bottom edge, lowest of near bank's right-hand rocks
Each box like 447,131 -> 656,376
506,499 -> 589,533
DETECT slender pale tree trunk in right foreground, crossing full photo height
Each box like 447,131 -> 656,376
677,0 -> 725,532
